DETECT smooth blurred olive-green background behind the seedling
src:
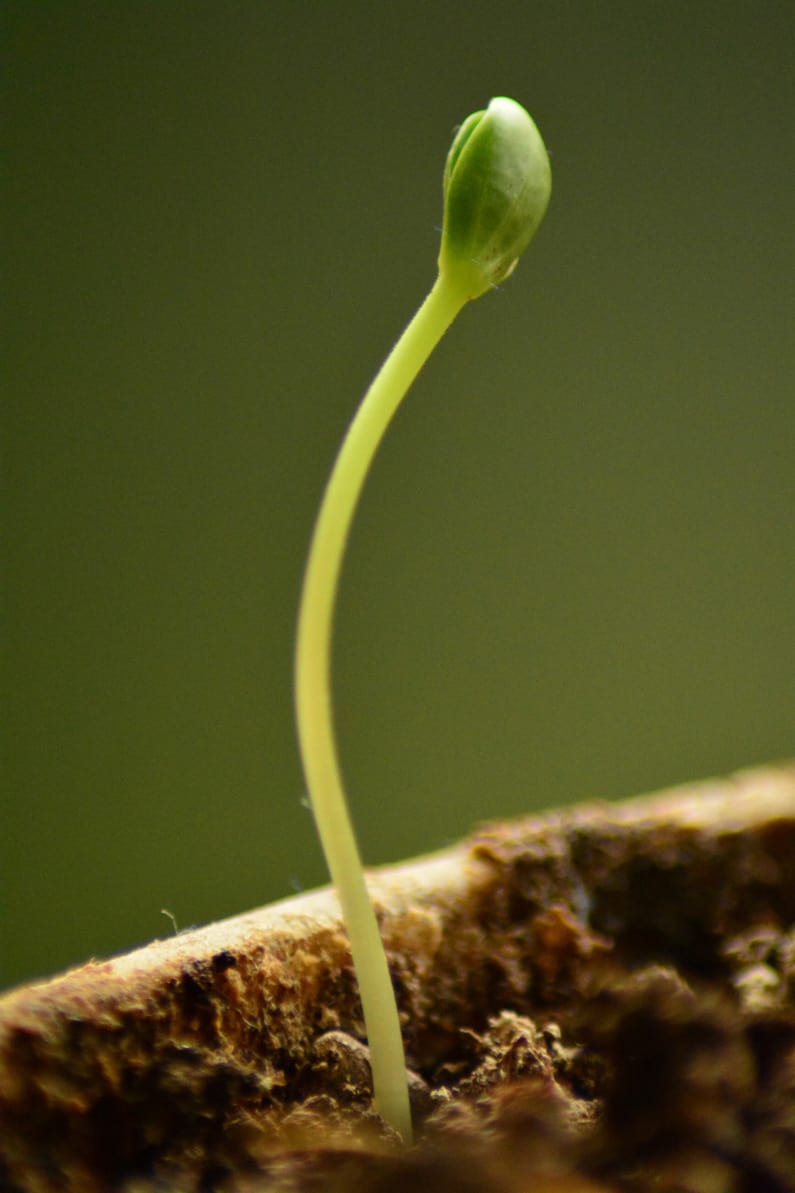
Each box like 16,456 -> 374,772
1,0 -> 795,983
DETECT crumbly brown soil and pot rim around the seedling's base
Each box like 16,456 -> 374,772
0,765 -> 795,1193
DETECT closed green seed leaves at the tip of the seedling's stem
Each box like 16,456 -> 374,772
439,98 -> 551,298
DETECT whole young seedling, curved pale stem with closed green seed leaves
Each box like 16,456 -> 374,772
295,98 -> 551,1143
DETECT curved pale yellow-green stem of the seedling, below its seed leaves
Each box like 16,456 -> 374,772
295,270 -> 467,1143
